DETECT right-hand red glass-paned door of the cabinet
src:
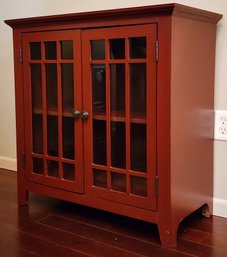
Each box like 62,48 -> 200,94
82,24 -> 157,210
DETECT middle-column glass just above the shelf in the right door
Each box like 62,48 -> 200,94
110,64 -> 125,116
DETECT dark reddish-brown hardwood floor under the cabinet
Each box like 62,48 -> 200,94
0,169 -> 227,257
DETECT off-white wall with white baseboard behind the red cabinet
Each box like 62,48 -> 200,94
0,0 -> 227,217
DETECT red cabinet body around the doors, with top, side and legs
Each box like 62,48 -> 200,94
6,4 -> 222,247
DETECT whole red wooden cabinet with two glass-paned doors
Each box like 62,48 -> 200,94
5,4 -> 222,247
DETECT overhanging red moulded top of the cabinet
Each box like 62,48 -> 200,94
5,3 -> 222,28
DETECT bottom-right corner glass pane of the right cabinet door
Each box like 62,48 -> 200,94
130,176 -> 147,196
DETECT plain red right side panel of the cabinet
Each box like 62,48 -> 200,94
171,17 -> 216,222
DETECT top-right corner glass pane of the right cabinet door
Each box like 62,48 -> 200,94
129,37 -> 146,59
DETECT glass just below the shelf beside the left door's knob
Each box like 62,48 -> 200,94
62,117 -> 75,159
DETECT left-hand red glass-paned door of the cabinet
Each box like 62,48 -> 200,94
22,30 -> 83,192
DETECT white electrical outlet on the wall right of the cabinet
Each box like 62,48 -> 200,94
214,110 -> 227,141
